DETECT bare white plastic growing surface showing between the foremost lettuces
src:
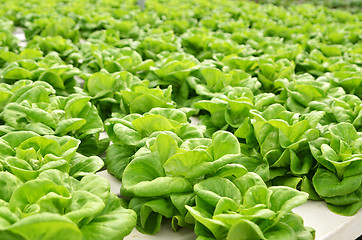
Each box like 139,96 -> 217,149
97,171 -> 362,240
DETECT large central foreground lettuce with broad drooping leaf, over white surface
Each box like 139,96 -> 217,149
121,131 -> 243,234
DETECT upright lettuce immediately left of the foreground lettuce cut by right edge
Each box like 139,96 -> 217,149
242,104 -> 324,187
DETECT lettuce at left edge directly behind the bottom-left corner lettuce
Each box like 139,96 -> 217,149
0,131 -> 103,181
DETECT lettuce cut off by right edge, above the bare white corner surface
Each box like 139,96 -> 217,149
309,123 -> 362,215
